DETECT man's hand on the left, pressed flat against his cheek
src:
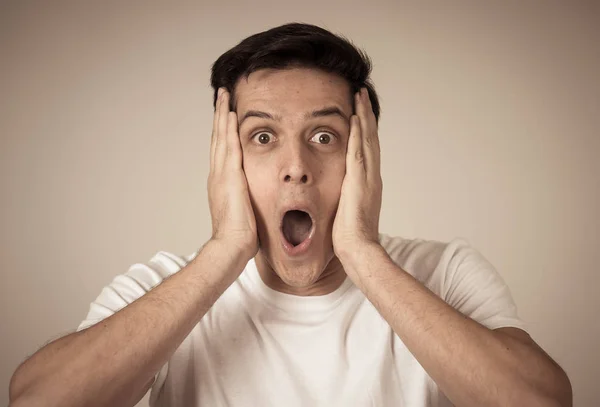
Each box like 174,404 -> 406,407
208,88 -> 258,260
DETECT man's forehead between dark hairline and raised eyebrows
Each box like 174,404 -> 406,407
235,68 -> 352,117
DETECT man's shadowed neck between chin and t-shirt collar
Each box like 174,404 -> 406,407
255,251 -> 346,296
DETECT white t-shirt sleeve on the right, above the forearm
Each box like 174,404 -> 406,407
434,239 -> 527,330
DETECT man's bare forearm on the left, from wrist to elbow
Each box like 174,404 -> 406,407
10,241 -> 247,406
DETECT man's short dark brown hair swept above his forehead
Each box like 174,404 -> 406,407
210,23 -> 380,122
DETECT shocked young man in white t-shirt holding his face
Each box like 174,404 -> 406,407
10,24 -> 571,407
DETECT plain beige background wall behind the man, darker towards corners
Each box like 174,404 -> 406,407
0,1 -> 600,406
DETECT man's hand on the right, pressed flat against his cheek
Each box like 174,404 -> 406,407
332,88 -> 383,263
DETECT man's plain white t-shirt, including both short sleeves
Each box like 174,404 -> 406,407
78,235 -> 525,407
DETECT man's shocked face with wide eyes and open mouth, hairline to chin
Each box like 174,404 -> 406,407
235,68 -> 353,287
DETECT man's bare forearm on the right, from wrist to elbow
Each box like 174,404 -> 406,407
342,246 -> 565,406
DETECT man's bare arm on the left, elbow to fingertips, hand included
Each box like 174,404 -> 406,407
9,85 -> 258,407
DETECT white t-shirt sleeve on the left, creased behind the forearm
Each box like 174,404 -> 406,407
77,252 -> 188,383
